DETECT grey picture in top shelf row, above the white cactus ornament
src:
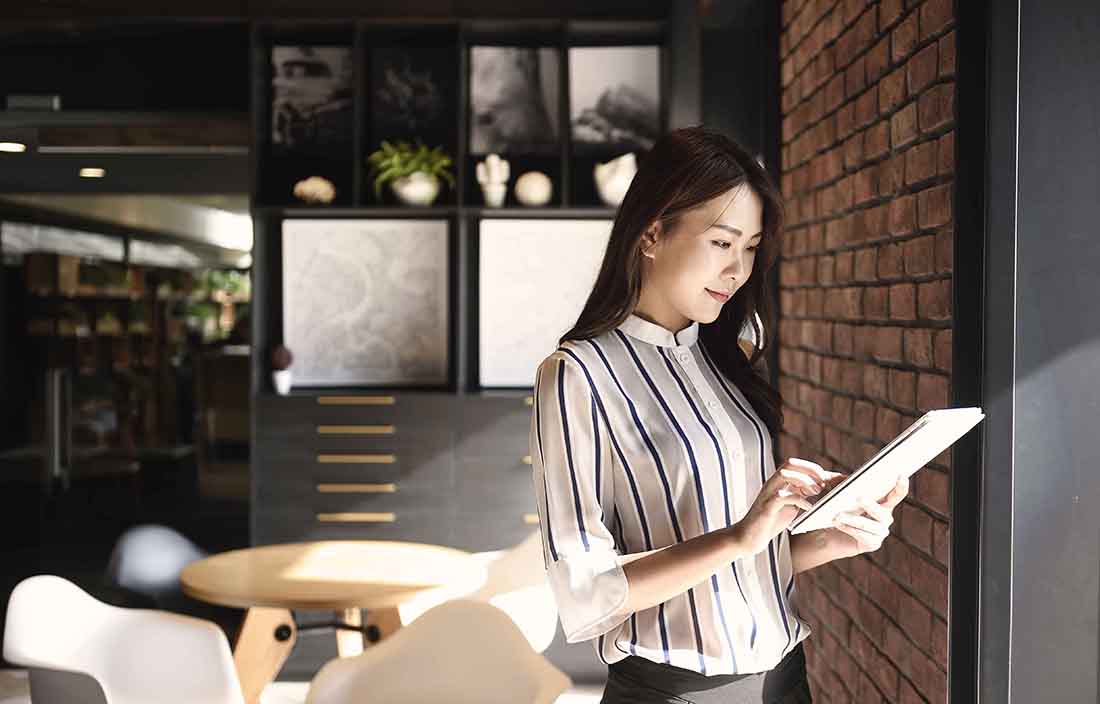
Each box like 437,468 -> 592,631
469,46 -> 561,154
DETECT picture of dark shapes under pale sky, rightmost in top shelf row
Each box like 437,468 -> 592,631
569,45 -> 661,154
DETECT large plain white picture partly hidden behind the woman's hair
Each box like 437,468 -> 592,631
477,218 -> 612,387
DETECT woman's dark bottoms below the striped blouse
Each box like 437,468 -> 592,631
601,642 -> 813,704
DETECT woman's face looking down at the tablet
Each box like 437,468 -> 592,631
635,186 -> 763,332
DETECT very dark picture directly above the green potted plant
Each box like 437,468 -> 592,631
367,46 -> 458,148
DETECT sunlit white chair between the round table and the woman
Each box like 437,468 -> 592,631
398,529 -> 558,652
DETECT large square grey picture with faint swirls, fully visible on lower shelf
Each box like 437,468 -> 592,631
283,219 -> 450,386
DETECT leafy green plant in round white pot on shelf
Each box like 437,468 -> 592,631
366,140 -> 454,206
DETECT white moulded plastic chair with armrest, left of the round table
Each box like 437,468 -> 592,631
3,574 -> 244,704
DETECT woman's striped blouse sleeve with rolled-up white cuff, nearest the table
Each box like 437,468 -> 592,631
530,351 -> 629,642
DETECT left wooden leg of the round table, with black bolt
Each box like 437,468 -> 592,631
233,607 -> 298,704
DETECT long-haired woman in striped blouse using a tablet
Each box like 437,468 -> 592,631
530,127 -> 909,704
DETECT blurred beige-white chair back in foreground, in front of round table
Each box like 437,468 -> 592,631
306,598 -> 573,704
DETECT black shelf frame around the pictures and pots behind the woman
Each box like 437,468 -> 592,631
250,18 -> 672,397
